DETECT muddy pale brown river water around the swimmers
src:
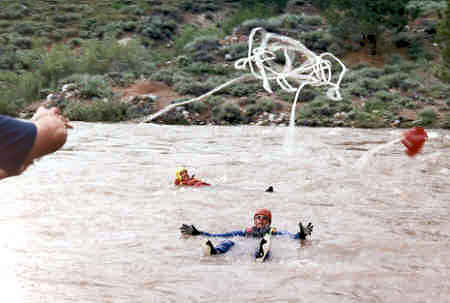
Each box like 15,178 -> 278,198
0,122 -> 450,303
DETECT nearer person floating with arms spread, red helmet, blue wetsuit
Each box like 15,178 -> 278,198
180,208 -> 314,259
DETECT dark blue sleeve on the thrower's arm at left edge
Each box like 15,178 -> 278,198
0,115 -> 37,175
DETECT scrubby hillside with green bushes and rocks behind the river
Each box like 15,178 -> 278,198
0,0 -> 450,128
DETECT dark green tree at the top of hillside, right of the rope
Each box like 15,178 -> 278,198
325,0 -> 418,55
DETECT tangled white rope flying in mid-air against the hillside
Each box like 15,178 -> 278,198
143,27 -> 347,124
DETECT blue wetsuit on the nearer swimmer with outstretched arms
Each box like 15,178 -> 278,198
199,226 -> 300,254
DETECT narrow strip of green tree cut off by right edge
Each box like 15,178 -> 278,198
438,0 -> 450,82
